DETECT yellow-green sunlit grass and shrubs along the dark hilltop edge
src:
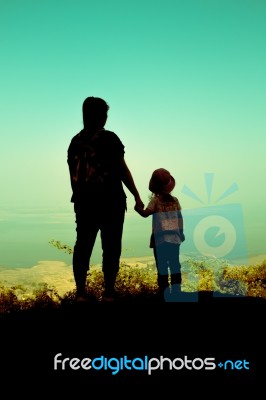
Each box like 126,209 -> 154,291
0,256 -> 266,314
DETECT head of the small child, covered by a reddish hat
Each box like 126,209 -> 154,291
149,168 -> 175,194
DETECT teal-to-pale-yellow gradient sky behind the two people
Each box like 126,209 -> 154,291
0,0 -> 266,260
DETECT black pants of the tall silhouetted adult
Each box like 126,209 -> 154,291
73,202 -> 126,293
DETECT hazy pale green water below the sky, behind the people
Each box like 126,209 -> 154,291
0,205 -> 266,268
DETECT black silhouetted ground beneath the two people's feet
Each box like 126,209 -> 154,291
0,294 -> 266,398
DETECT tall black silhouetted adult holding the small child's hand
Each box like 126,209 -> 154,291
67,97 -> 144,301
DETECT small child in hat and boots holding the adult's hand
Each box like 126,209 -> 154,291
135,168 -> 185,299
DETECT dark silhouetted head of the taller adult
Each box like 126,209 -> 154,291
82,96 -> 109,129
